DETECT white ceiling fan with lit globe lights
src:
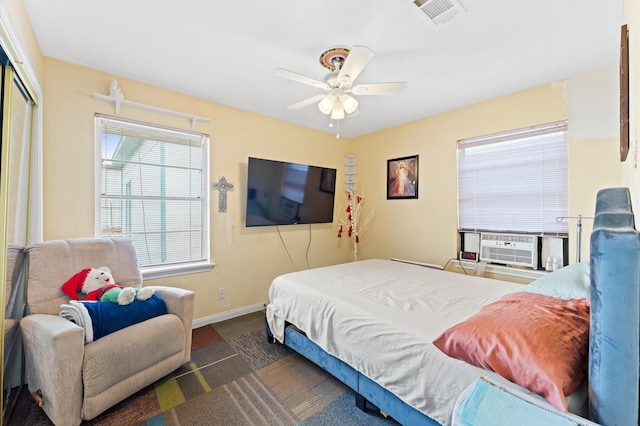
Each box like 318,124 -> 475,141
275,46 -> 407,120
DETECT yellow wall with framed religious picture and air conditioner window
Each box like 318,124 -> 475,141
354,79 -> 620,265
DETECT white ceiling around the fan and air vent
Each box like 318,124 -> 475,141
24,0 -> 622,137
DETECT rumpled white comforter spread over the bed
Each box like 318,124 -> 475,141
267,259 -> 522,425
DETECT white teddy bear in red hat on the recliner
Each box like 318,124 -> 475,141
62,266 -> 154,305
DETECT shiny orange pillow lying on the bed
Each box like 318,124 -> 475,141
433,292 -> 589,412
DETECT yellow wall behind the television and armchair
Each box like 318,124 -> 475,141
43,58 -> 351,319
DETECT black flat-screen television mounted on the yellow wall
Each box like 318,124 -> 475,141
246,157 -> 336,226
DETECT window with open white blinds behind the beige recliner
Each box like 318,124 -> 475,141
94,114 -> 209,271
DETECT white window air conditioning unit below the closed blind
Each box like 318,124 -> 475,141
480,232 -> 538,269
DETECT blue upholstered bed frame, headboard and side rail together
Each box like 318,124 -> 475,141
265,188 -> 640,426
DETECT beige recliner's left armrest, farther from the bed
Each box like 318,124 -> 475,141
20,314 -> 84,424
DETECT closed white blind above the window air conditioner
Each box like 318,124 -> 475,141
457,122 -> 568,235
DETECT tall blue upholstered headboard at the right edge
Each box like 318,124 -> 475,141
589,188 -> 640,426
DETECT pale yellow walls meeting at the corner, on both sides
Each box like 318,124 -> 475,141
6,0 -> 640,319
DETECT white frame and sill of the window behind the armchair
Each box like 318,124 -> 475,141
94,113 -> 214,279
